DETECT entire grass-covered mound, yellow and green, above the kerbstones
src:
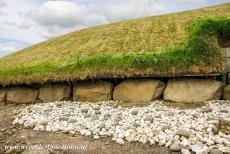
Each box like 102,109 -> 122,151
0,3 -> 230,85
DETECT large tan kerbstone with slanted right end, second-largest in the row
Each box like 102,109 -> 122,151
113,79 -> 165,102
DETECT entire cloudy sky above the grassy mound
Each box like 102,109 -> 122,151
0,0 -> 230,57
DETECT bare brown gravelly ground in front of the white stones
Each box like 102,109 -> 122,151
0,105 -> 170,154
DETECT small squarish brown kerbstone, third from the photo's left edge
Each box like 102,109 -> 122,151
39,84 -> 71,102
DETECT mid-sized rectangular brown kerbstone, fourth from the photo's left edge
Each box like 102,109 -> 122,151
73,81 -> 113,102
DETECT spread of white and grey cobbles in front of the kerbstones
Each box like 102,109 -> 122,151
13,101 -> 230,154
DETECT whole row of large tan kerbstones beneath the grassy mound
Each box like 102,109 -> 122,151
0,79 -> 227,104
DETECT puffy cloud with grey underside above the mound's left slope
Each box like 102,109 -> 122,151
26,0 -> 107,38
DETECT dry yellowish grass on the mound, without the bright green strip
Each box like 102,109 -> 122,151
0,3 -> 230,84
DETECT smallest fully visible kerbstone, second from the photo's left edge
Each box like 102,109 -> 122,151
6,88 -> 39,103
